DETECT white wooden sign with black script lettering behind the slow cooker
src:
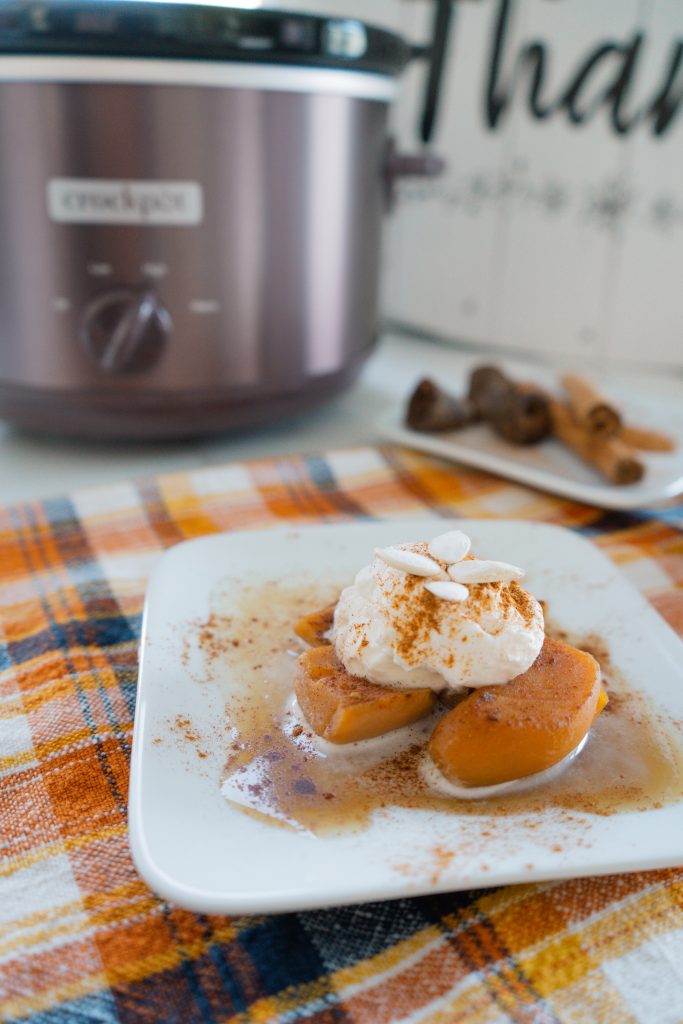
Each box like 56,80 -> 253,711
385,0 -> 683,369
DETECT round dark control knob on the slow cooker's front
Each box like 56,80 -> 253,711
81,288 -> 171,374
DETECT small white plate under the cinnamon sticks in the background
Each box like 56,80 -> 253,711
379,380 -> 683,509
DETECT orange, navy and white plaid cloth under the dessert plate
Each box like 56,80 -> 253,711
0,449 -> 683,1024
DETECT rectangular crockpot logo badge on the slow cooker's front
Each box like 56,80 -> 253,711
47,178 -> 204,226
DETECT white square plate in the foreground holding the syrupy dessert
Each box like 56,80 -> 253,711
130,516 -> 683,913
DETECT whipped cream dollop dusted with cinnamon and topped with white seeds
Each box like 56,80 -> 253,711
332,530 -> 544,691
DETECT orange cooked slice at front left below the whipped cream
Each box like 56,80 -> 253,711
294,645 -> 436,743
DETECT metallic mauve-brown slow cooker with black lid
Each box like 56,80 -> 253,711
0,0 -> 450,437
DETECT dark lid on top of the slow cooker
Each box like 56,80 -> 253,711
0,0 -> 412,75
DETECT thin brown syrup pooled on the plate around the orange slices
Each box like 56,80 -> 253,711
181,581 -> 683,836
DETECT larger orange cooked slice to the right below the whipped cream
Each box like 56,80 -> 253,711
429,637 -> 607,785
